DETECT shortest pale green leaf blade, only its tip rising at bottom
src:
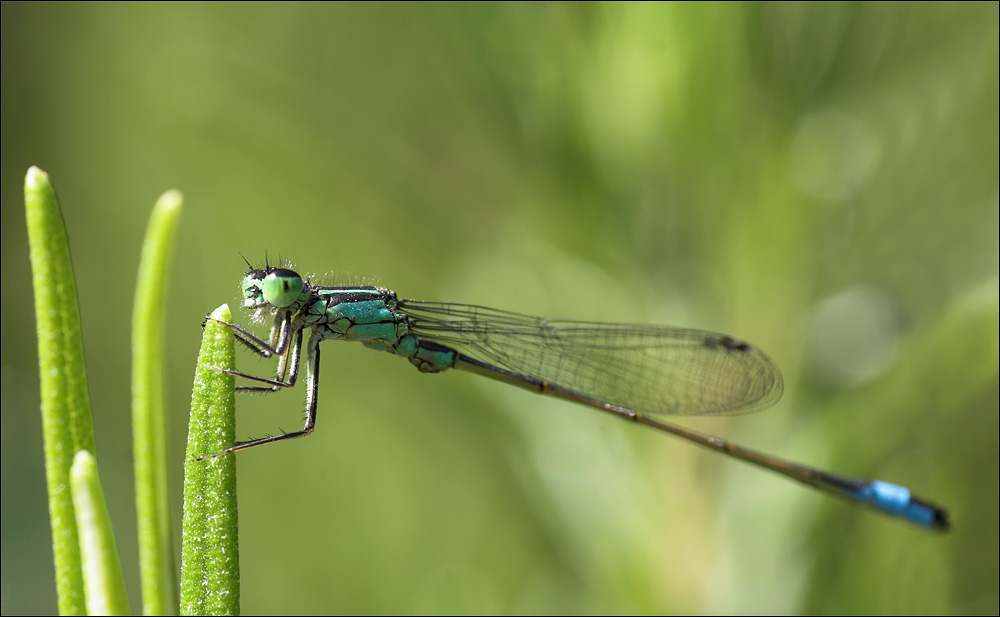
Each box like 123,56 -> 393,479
70,450 -> 129,615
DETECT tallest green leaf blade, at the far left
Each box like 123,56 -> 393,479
24,167 -> 94,615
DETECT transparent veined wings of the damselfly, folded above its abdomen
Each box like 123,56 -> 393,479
399,300 -> 782,415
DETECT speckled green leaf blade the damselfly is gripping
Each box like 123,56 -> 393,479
181,305 -> 240,615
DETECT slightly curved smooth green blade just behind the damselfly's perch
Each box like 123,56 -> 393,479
132,191 -> 183,615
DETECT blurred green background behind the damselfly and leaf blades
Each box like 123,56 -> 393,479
0,3 -> 1000,614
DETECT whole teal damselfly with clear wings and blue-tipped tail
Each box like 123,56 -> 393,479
201,259 -> 949,530
